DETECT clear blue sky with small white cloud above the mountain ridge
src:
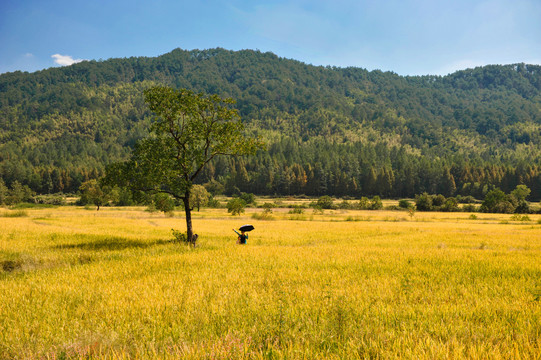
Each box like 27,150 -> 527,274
0,0 -> 541,75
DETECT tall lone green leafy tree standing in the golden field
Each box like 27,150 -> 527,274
106,86 -> 263,245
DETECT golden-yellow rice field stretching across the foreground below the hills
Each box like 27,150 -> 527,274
0,206 -> 541,359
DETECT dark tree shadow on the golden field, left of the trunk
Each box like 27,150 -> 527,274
52,235 -> 171,251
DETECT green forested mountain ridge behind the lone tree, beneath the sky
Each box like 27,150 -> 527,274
0,49 -> 541,200
